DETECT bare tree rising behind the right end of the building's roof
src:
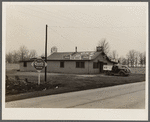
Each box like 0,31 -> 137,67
98,39 -> 110,54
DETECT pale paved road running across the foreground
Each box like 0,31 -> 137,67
5,82 -> 145,109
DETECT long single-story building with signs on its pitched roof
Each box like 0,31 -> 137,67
20,47 -> 117,74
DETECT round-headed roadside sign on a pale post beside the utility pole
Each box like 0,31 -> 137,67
31,58 -> 47,85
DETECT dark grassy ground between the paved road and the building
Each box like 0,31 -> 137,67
6,70 -> 145,100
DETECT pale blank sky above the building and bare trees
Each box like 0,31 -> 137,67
3,2 -> 148,56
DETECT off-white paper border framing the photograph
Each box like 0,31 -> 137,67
2,2 -> 149,120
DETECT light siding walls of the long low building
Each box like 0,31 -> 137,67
20,55 -> 113,74
